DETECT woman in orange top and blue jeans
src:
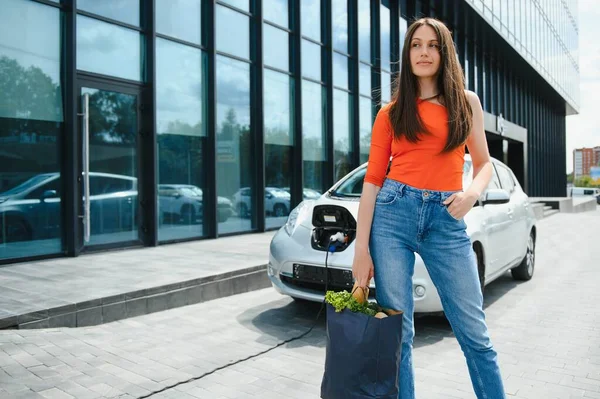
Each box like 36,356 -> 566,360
352,18 -> 505,399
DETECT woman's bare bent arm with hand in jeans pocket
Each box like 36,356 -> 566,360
444,91 -> 493,219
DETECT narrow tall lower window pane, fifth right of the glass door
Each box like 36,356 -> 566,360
333,89 -> 353,182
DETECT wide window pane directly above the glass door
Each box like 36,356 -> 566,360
77,15 -> 142,81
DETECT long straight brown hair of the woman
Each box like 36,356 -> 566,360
390,18 -> 473,152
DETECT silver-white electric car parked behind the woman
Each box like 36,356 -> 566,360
267,155 -> 537,313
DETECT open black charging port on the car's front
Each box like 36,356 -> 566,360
311,205 -> 356,252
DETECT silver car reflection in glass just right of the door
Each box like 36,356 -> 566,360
158,184 -> 233,223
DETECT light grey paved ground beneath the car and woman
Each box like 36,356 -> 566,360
0,211 -> 600,399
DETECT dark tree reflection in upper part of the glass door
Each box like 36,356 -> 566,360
90,90 -> 137,144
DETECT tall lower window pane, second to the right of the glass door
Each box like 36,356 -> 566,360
216,56 -> 256,234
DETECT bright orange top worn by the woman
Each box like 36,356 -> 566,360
365,100 -> 465,191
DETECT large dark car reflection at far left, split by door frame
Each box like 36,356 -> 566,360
0,172 -> 138,242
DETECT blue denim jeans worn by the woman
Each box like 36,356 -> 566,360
369,179 -> 505,399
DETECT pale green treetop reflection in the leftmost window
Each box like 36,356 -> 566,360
0,56 -> 63,122
